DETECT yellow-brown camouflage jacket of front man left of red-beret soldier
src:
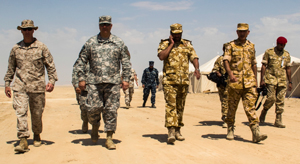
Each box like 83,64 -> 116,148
223,40 -> 257,89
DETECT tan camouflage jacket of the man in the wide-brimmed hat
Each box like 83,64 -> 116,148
4,38 -> 57,93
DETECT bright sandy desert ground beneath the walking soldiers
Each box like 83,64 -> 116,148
0,86 -> 300,164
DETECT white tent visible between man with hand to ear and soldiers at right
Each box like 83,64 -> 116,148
189,55 -> 219,93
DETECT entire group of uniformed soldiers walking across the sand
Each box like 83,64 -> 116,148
4,16 -> 291,152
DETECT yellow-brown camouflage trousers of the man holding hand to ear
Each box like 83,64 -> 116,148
163,84 -> 189,127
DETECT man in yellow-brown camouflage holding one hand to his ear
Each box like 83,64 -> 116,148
158,23 -> 200,143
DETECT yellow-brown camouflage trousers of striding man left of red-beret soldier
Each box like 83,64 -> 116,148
225,87 -> 258,127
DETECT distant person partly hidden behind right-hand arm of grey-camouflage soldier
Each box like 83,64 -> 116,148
122,68 -> 139,109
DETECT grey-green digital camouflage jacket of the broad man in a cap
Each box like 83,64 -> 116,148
76,33 -> 131,84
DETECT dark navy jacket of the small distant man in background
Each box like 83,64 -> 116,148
142,67 -> 159,86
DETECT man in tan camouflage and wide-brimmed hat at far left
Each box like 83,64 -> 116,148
4,20 -> 57,152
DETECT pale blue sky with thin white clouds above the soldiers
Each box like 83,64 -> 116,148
0,0 -> 300,85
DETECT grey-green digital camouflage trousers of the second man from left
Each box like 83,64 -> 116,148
86,84 -> 120,132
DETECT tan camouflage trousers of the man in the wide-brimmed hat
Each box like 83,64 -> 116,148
13,91 -> 45,138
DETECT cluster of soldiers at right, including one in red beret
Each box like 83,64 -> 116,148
212,23 -> 292,142
